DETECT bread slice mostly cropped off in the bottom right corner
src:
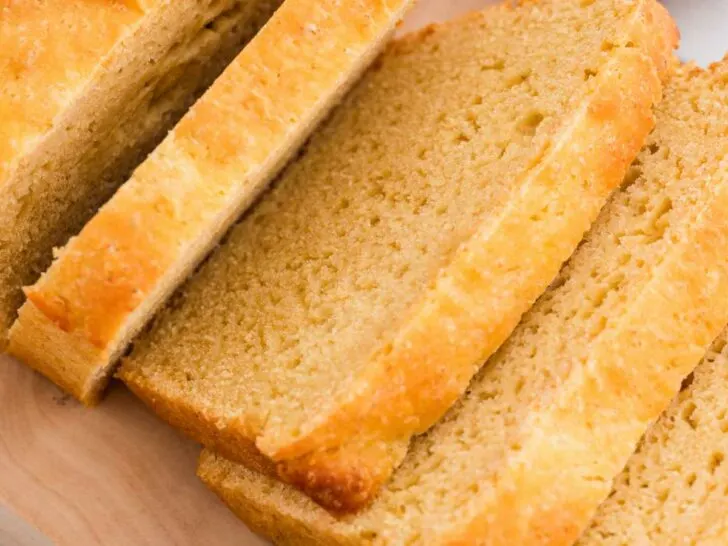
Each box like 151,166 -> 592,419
577,331 -> 728,546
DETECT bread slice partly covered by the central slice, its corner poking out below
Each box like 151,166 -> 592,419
200,59 -> 728,546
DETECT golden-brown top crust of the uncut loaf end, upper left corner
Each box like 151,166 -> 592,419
0,0 -> 143,184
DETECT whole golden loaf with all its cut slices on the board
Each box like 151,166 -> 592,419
0,0 -> 728,546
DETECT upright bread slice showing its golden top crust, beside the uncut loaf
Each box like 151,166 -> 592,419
5,0 -> 411,404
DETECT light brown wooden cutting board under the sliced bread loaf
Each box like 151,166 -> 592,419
0,0 -> 492,546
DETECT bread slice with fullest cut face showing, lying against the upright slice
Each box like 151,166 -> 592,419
121,0 -> 676,510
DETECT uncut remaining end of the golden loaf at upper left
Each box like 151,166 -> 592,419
0,0 -> 279,349
